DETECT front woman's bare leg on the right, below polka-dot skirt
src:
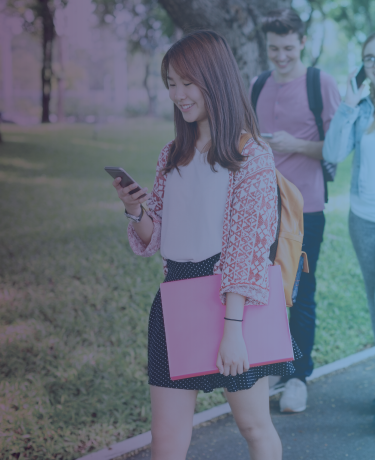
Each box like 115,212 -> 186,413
225,377 -> 282,460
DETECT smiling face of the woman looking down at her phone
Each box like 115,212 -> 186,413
167,65 -> 207,123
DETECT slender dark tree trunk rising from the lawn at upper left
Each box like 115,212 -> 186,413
39,0 -> 55,123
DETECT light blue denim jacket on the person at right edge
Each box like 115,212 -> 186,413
323,97 -> 374,197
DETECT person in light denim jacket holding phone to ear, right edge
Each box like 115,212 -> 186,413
323,33 -> 375,344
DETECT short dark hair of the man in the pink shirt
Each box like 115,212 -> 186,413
262,8 -> 305,40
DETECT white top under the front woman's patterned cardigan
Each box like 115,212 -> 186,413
160,149 -> 229,262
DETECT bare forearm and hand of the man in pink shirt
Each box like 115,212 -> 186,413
268,131 -> 324,160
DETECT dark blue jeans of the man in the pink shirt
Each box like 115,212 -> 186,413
283,211 -> 325,381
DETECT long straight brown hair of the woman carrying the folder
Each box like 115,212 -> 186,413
161,30 -> 259,173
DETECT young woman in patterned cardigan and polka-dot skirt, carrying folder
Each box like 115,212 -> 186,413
113,31 -> 299,460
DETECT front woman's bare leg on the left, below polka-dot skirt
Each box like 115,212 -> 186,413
150,385 -> 198,460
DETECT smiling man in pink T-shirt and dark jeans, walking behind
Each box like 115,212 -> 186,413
250,9 -> 341,412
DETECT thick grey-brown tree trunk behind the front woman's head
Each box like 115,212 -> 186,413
159,0 -> 291,88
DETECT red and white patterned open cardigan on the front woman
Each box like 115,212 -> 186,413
128,139 -> 277,305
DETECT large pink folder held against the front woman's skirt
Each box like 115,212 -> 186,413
160,265 -> 294,380
